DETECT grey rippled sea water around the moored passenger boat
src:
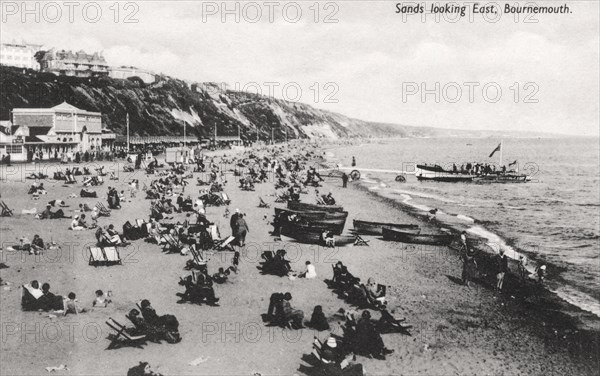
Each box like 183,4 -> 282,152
330,138 -> 600,316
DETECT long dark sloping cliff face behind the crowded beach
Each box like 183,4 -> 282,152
0,67 -> 420,140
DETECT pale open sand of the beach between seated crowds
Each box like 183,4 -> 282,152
0,145 -> 598,375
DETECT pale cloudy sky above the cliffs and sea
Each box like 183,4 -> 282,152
0,0 -> 600,136
